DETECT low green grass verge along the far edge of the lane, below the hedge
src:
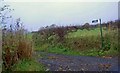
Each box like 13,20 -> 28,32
36,45 -> 118,56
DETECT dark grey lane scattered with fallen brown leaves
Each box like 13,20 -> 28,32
37,52 -> 118,71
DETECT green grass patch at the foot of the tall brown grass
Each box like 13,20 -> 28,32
12,59 -> 45,71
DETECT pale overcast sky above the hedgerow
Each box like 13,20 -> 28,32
0,0 -> 118,31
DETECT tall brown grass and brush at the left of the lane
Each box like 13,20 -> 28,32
2,22 -> 32,70
